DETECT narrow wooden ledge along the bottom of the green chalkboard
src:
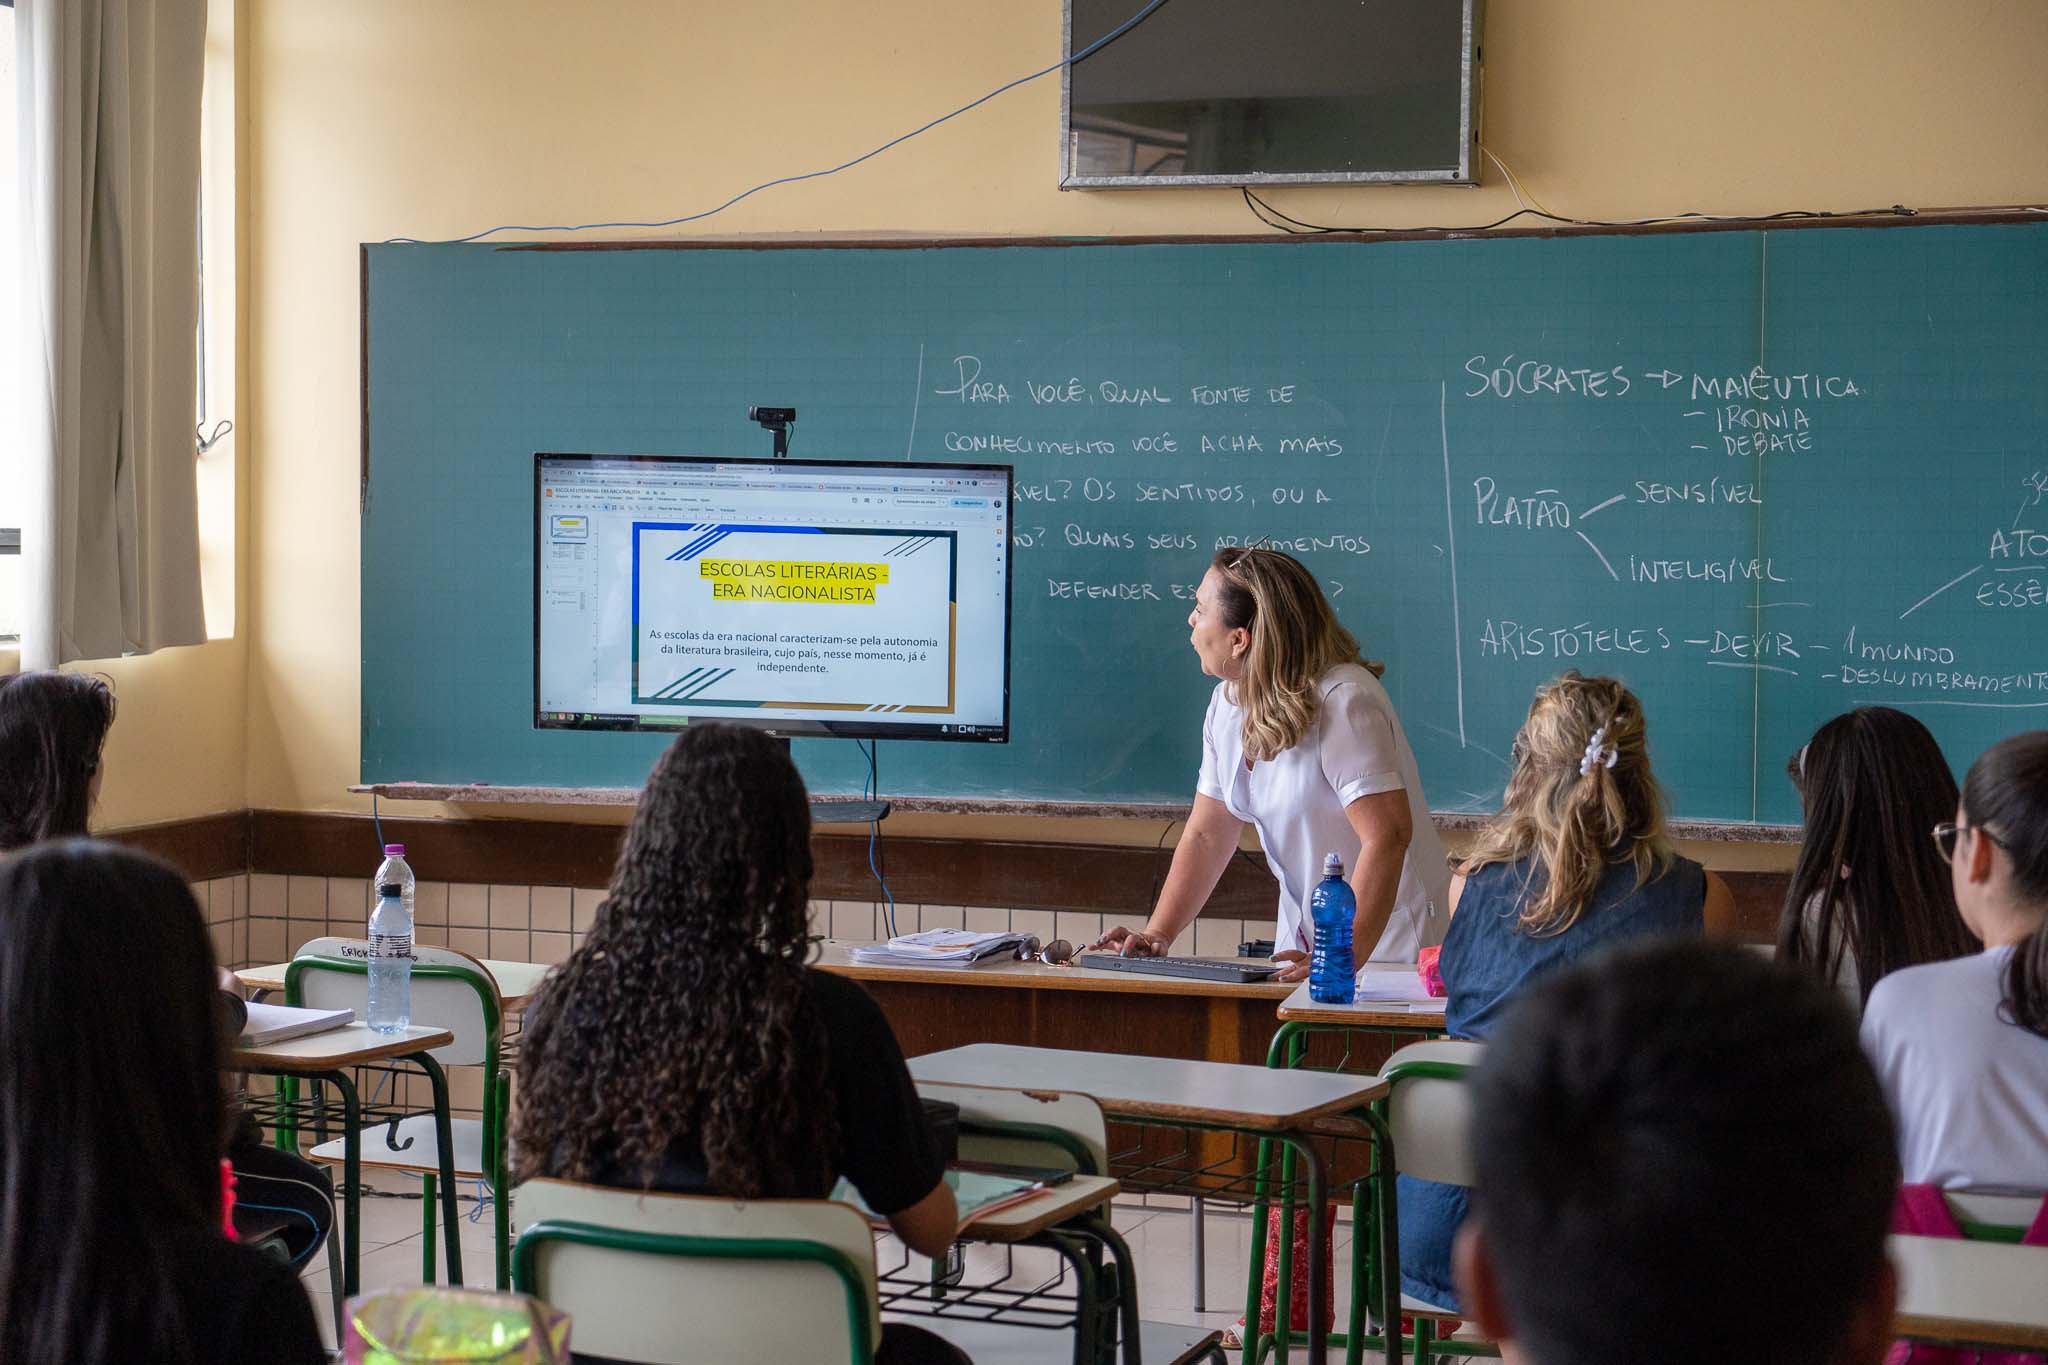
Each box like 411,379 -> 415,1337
348,782 -> 1802,843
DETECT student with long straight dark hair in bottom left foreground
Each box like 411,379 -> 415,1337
0,839 -> 326,1365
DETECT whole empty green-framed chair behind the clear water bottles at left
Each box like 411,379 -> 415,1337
285,937 -> 512,1289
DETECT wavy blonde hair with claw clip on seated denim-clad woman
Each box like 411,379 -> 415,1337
1454,671 -> 1673,933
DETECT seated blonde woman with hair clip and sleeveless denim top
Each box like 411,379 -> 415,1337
1399,671 -> 1735,1310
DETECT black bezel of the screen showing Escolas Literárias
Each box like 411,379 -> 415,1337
530,450 -> 1016,745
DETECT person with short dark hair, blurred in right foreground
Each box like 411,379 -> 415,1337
1458,941 -> 1898,1365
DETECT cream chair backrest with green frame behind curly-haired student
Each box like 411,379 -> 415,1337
512,1181 -> 881,1365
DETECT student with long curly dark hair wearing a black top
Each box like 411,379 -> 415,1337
512,724 -> 963,1365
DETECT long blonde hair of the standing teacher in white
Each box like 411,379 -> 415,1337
1210,544 -> 1386,763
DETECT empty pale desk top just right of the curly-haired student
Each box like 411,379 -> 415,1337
909,1044 -> 1386,1132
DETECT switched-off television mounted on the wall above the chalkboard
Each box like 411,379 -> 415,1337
1059,0 -> 1483,188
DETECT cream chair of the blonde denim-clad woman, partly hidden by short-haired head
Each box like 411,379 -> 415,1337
1378,1040 -> 1501,1365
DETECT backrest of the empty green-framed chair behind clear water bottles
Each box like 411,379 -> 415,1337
285,937 -> 504,1076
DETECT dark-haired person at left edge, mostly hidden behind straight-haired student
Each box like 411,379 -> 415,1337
0,673 -> 334,1265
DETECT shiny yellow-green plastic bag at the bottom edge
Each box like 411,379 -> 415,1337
342,1285 -> 569,1365
